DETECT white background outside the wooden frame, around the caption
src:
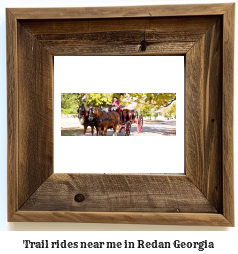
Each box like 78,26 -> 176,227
0,0 -> 238,253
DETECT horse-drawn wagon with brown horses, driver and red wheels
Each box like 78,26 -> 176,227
78,105 -> 143,136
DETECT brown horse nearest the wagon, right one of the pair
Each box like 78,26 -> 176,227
88,106 -> 120,136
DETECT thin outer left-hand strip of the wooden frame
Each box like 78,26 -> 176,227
6,10 -> 19,220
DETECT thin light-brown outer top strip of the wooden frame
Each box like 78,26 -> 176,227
9,3 -> 232,20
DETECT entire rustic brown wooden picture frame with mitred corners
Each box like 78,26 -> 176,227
6,3 -> 235,226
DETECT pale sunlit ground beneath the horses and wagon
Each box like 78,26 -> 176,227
61,117 -> 176,136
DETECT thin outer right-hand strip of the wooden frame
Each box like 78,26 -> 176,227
222,4 -> 235,225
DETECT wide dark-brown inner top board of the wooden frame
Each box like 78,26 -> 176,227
21,16 -> 218,56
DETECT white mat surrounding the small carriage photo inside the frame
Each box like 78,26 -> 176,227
54,56 -> 184,173
